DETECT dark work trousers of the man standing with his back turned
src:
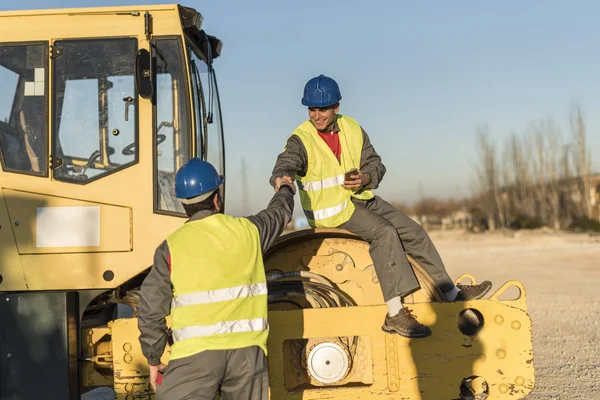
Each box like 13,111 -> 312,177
156,346 -> 269,400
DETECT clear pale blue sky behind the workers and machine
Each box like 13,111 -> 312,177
1,0 -> 600,214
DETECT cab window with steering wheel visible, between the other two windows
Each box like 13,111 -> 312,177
52,38 -> 138,184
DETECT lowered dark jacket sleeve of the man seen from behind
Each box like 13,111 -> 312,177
138,241 -> 173,365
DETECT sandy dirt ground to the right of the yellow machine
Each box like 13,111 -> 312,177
431,232 -> 600,400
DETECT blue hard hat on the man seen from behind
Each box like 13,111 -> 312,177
175,157 -> 224,199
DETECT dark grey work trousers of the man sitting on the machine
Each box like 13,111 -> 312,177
340,196 -> 454,301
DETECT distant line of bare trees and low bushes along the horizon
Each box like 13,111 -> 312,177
394,105 -> 600,230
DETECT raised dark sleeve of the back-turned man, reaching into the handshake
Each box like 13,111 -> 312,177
248,185 -> 294,253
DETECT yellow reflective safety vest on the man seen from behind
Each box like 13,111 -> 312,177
167,214 -> 269,359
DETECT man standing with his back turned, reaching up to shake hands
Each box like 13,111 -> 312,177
138,158 -> 295,400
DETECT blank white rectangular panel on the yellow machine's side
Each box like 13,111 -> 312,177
36,206 -> 100,247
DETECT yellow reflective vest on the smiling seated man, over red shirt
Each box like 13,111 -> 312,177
292,115 -> 373,228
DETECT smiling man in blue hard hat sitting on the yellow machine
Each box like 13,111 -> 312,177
270,75 -> 492,338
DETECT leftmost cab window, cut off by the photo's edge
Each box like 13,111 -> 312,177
0,44 -> 48,176
